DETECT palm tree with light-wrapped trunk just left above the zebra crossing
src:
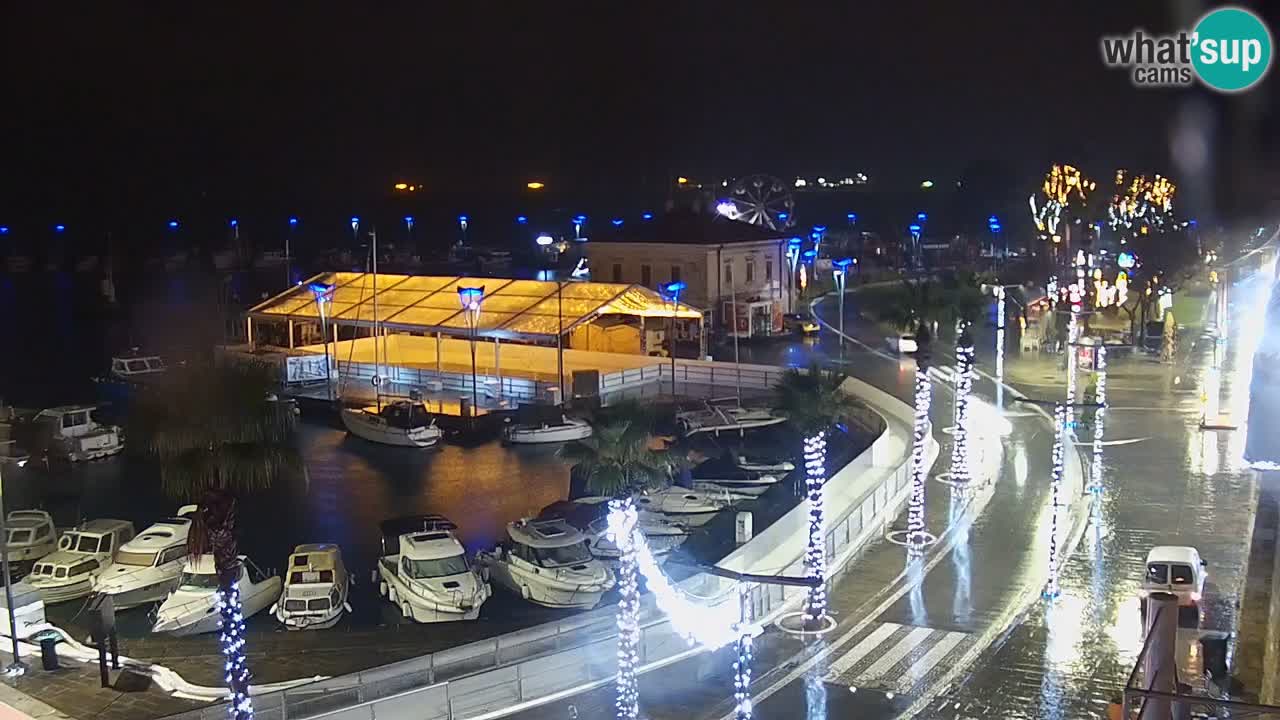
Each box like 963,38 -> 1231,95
774,365 -> 860,629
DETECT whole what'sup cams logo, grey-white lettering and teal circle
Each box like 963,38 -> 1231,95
1102,8 -> 1272,92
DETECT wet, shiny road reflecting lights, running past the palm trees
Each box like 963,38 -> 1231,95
520,263 -> 1270,720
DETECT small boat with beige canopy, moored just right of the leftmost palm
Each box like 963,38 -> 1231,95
271,543 -> 351,630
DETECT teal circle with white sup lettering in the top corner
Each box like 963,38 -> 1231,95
1192,8 -> 1271,92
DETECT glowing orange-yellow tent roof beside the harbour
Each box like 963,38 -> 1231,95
248,273 -> 701,341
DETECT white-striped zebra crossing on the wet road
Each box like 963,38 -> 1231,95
823,623 -> 969,694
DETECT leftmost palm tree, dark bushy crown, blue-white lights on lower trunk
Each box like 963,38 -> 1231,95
128,363 -> 301,720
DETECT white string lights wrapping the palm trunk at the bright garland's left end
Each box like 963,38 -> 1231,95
609,498 -> 640,720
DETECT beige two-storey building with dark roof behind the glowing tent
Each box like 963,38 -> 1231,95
586,210 -> 790,337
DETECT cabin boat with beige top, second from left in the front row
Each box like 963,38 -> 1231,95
27,520 -> 133,603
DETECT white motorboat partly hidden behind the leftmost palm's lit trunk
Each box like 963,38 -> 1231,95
151,555 -> 280,635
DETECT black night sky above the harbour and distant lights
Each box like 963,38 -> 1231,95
0,1 -> 1274,233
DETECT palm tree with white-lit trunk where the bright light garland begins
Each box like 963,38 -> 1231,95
559,402 -> 676,717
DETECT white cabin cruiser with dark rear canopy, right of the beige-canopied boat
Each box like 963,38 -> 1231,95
378,515 -> 490,623
